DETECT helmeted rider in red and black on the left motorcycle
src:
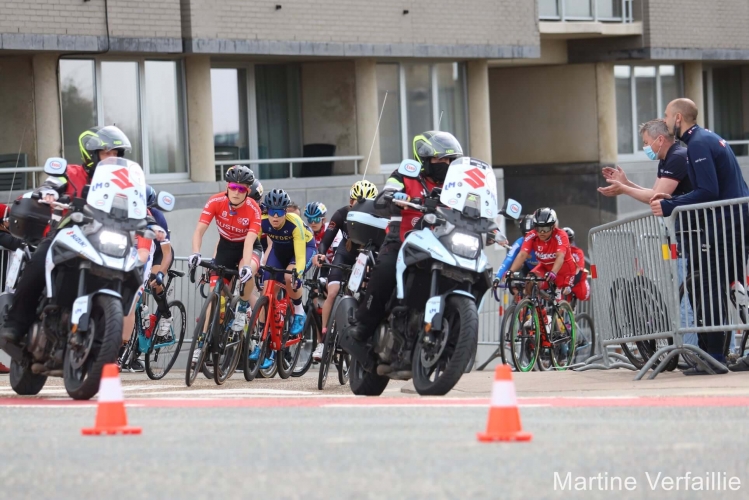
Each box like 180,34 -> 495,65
0,125 -> 132,344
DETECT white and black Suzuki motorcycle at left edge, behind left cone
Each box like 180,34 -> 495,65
0,158 -> 164,400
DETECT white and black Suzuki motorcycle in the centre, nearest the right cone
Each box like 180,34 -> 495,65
333,157 -> 520,396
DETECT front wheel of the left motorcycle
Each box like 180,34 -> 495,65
63,295 -> 122,399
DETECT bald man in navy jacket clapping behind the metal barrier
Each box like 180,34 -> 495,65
650,98 -> 749,375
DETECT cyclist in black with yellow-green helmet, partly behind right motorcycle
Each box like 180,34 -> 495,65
312,180 -> 377,361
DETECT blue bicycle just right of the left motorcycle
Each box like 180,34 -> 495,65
119,269 -> 187,380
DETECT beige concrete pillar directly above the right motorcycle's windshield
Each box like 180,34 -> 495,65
468,59 -> 492,165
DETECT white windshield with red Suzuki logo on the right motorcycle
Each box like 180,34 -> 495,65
440,156 -> 497,219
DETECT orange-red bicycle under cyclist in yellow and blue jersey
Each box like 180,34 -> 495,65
242,266 -> 302,382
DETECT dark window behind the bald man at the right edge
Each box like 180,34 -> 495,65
703,66 -> 749,156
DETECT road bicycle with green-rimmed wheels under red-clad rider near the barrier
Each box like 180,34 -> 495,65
508,275 -> 577,372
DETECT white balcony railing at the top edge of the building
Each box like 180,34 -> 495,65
538,0 -> 633,23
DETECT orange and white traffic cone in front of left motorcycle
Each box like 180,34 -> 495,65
81,364 -> 141,436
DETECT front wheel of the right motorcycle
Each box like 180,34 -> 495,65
412,295 -> 479,396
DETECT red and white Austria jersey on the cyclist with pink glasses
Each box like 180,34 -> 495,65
200,193 -> 262,241
